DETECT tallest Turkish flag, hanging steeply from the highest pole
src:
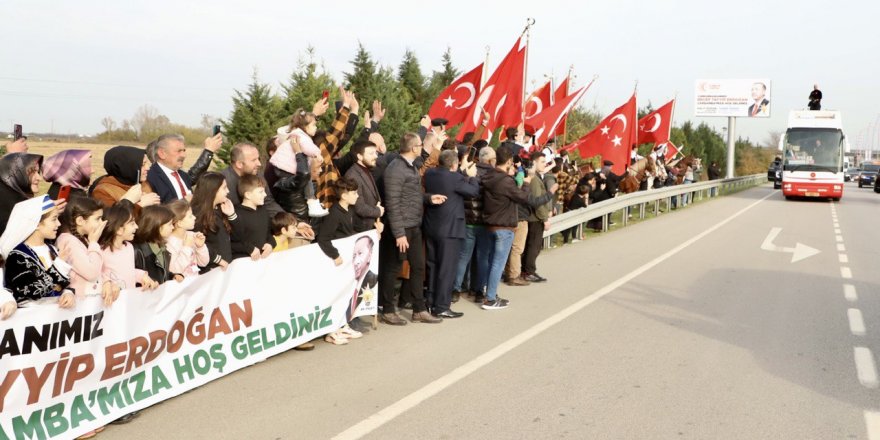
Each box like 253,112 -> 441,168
459,38 -> 526,139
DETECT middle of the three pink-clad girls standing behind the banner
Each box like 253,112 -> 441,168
98,202 -> 159,290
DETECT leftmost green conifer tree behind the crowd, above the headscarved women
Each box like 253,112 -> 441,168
214,69 -> 284,168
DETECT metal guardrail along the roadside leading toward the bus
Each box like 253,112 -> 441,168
544,173 -> 767,241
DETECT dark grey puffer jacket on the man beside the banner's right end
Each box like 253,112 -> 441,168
382,156 -> 430,238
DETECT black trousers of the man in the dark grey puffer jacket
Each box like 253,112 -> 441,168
379,227 -> 427,313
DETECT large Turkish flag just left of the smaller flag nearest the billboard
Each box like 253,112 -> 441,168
564,94 -> 638,174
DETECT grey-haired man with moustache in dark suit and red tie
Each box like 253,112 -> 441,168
147,134 -> 193,203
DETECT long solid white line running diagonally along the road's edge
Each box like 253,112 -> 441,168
333,192 -> 776,439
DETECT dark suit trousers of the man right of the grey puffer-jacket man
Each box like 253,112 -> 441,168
425,237 -> 464,313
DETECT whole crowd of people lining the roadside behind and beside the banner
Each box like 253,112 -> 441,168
0,87 -> 712,436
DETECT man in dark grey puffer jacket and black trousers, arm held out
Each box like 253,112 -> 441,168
379,133 -> 446,325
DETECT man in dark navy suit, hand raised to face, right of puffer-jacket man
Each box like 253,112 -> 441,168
422,150 -> 480,318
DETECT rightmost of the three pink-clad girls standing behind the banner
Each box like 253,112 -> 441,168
166,200 -> 211,277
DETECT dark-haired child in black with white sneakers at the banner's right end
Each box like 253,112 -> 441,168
317,177 -> 363,345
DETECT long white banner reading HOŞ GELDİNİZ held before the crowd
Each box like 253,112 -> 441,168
0,231 -> 379,440
